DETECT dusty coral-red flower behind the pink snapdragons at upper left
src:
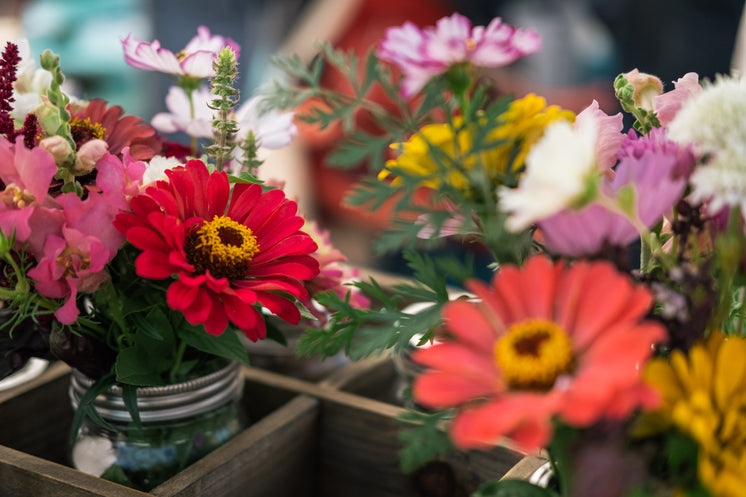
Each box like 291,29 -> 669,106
70,98 -> 162,160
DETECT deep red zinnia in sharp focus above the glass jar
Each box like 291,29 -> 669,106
115,160 -> 319,341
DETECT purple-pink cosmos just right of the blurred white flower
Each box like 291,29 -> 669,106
538,128 -> 694,257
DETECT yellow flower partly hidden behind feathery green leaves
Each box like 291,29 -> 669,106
378,94 -> 575,189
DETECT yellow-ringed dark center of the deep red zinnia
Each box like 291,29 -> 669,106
185,216 -> 259,280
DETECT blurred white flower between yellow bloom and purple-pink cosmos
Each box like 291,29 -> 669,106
498,116 -> 599,231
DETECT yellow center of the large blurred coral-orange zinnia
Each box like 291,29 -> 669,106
495,319 -> 575,390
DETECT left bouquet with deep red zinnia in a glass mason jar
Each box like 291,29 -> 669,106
0,27 -> 365,489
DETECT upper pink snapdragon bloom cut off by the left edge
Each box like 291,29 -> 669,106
0,137 -> 57,242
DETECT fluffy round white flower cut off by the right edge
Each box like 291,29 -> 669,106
668,76 -> 746,213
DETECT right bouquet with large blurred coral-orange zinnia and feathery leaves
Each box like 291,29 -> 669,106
270,14 -> 746,497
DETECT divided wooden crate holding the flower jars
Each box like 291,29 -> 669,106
0,361 -> 525,497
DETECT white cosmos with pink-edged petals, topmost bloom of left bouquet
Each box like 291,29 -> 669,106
122,26 -> 240,78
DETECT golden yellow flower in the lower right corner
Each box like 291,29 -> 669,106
644,332 -> 746,497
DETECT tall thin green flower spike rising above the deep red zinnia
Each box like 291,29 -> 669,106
206,47 -> 238,171
